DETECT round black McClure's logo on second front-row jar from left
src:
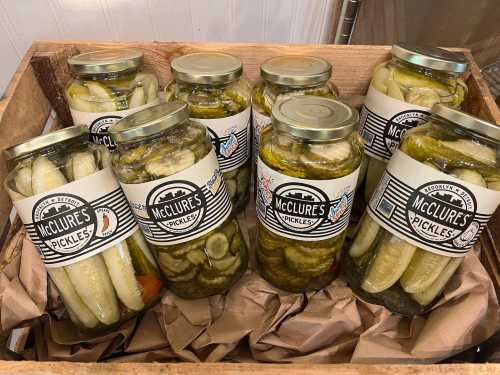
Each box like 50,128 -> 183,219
146,180 -> 207,234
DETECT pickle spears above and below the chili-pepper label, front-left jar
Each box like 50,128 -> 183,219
6,145 -> 162,330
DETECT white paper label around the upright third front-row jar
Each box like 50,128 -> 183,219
256,157 -> 359,241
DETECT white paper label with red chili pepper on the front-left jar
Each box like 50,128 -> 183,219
14,168 -> 138,268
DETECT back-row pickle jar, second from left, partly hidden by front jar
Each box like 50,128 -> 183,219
165,52 -> 251,213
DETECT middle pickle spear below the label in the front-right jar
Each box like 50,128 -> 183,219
399,249 -> 450,293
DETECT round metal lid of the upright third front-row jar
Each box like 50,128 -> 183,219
272,96 -> 359,141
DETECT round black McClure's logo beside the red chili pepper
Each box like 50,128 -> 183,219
32,193 -> 97,254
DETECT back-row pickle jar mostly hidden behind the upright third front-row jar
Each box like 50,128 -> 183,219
252,55 -> 339,166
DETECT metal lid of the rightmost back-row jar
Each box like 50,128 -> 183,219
391,43 -> 469,73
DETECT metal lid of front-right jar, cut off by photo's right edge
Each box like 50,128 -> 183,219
431,103 -> 500,142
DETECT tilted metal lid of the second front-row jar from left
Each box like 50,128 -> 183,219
108,100 -> 189,142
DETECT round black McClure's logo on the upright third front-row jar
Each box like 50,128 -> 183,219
271,182 -> 330,232
